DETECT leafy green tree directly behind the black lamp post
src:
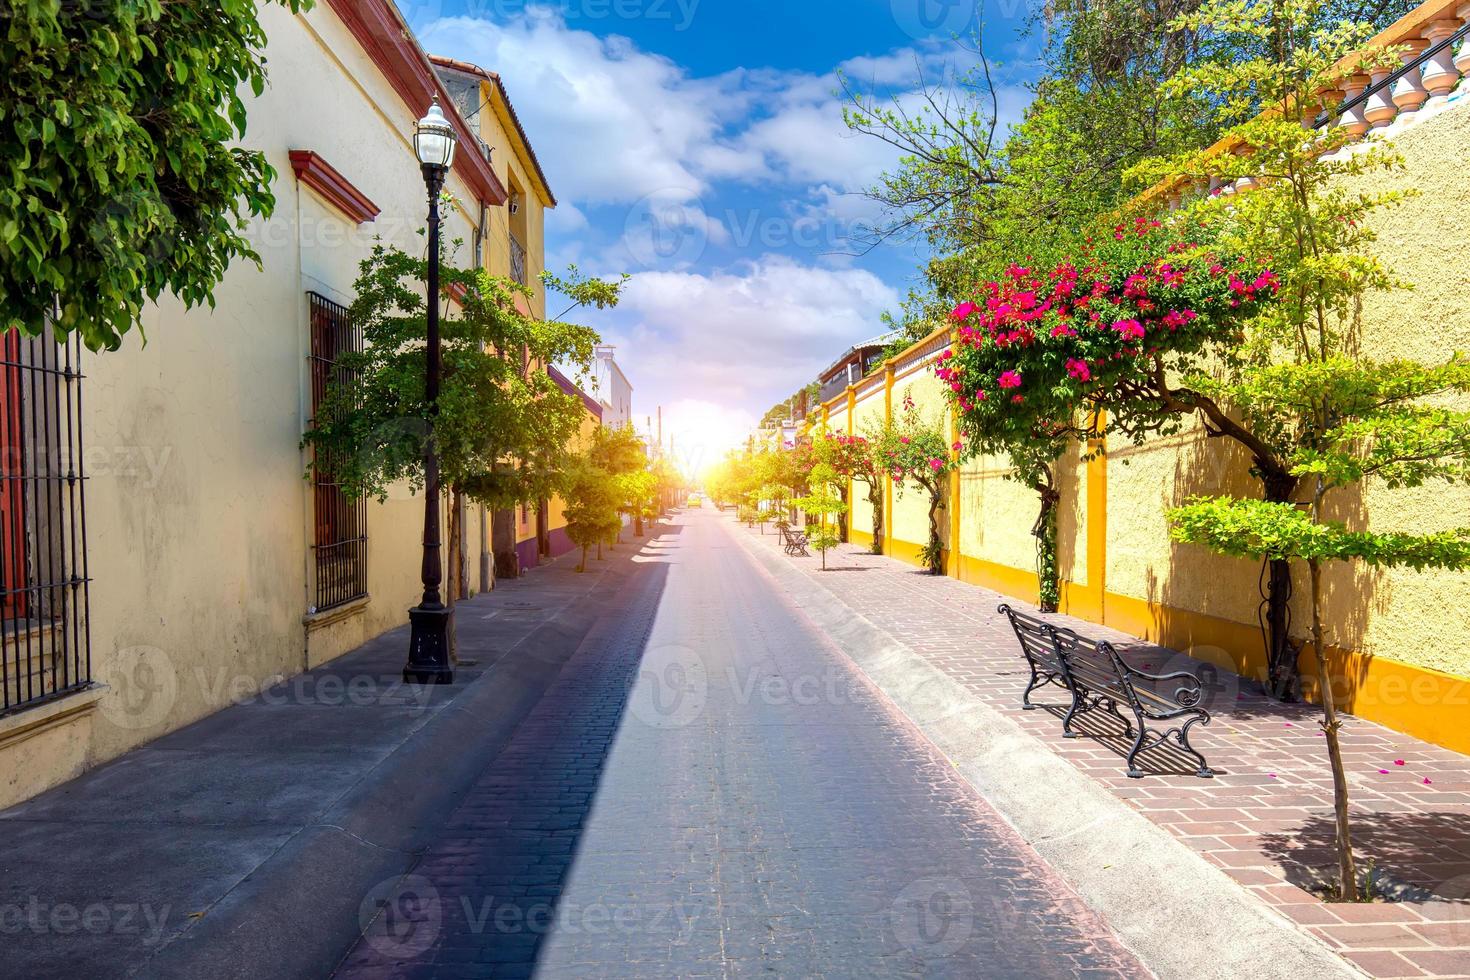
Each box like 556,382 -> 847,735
303,245 -> 597,599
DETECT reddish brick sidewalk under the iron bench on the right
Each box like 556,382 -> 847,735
744,517 -> 1470,977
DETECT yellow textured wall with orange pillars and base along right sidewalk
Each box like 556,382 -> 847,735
823,0 -> 1470,751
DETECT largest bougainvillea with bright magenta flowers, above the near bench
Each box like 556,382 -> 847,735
935,206 -> 1277,611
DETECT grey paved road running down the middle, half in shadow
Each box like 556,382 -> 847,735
338,511 -> 1147,977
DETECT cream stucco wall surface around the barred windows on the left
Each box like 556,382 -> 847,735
0,4 -> 502,805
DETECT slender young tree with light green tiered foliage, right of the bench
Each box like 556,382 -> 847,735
1161,0 -> 1470,901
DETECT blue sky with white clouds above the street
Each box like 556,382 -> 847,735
400,0 -> 1035,467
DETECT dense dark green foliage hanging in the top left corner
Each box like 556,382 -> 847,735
0,0 -> 312,350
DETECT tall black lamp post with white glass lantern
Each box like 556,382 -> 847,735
403,98 -> 454,685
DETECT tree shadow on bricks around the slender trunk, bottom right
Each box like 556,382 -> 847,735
1261,811 -> 1470,905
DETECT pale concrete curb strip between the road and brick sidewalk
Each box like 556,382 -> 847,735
726,525 -> 1366,980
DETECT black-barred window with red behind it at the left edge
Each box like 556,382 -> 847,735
0,331 -> 91,714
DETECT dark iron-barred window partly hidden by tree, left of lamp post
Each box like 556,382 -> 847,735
307,292 -> 368,613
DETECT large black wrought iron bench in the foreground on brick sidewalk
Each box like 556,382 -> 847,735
1000,605 -> 1214,779
